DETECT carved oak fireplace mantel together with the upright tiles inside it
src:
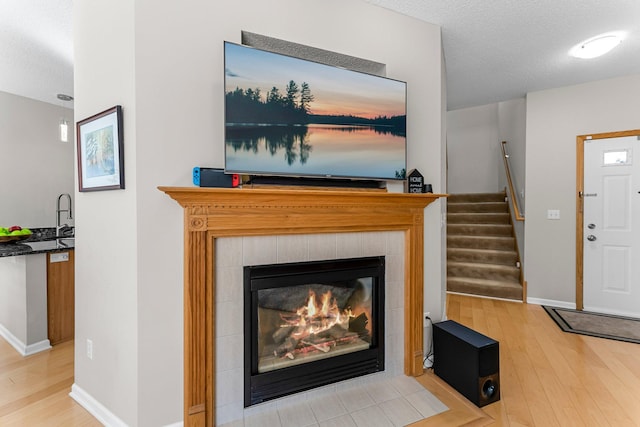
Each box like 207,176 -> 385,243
159,187 -> 442,426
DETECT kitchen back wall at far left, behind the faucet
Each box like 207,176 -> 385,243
0,92 -> 75,227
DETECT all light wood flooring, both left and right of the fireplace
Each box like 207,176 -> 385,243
5,295 -> 640,427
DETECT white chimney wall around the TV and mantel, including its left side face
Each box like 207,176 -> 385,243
74,0 -> 443,426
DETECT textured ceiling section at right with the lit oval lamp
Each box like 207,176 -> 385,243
366,0 -> 640,110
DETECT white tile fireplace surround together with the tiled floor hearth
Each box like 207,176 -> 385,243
215,231 -> 446,427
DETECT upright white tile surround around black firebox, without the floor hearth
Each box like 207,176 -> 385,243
215,231 -> 404,425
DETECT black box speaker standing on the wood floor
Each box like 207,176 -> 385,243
433,320 -> 500,407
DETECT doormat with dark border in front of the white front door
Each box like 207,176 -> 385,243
542,305 -> 640,344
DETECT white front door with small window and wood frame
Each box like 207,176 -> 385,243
583,136 -> 640,317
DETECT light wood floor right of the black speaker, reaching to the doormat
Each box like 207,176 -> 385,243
447,295 -> 640,427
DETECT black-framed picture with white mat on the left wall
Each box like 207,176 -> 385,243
76,105 -> 124,192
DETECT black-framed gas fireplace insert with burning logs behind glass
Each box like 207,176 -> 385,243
245,257 -> 385,406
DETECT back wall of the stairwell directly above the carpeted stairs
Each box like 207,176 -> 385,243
447,104 -> 502,194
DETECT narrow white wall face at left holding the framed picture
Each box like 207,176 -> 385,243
73,0 -> 138,426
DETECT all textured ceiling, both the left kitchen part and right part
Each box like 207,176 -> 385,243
0,0 -> 640,110
